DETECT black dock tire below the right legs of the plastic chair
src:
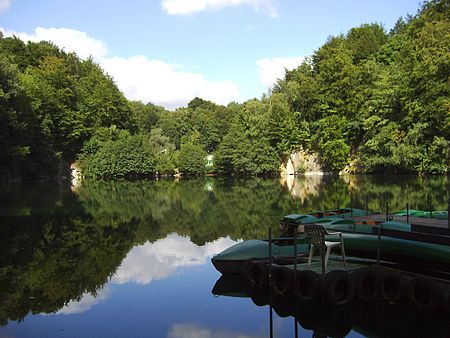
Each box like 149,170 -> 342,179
323,270 -> 355,306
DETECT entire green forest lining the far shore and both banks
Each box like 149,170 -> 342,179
0,0 -> 450,181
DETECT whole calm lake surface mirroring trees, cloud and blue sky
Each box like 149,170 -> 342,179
0,176 -> 449,338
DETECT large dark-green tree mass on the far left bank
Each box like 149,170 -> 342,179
0,37 -> 136,178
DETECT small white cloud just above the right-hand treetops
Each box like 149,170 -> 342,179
256,56 -> 305,88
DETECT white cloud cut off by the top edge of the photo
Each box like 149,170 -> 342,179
161,0 -> 278,17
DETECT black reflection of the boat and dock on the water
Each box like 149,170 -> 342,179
212,275 -> 450,337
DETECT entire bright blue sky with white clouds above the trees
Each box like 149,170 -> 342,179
0,0 -> 420,109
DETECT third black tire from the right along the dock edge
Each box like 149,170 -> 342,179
350,268 -> 380,302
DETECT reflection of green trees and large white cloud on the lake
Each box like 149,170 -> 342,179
0,176 -> 449,337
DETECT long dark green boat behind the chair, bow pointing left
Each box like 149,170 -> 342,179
212,215 -> 450,274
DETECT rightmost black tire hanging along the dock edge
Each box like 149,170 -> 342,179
407,277 -> 443,310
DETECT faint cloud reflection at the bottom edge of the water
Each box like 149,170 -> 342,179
168,323 -> 267,338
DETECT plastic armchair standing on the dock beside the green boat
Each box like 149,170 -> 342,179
305,224 -> 347,269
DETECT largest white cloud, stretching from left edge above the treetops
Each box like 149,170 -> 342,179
0,28 -> 242,109
